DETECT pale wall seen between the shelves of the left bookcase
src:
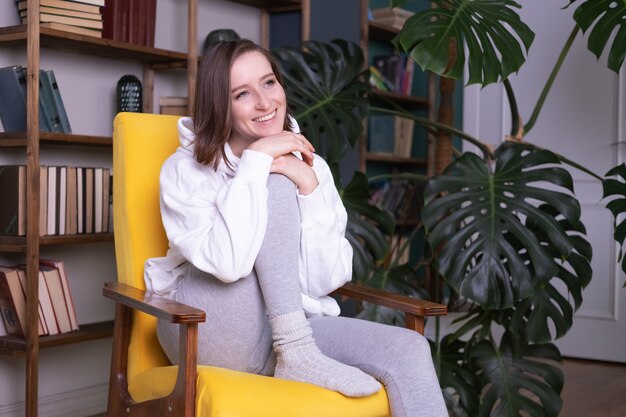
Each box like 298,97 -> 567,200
0,0 -> 260,417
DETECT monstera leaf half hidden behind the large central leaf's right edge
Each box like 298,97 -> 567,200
509,205 -> 592,343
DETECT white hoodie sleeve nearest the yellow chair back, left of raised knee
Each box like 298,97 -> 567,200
160,150 -> 272,282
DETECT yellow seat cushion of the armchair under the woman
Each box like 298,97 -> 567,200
128,366 -> 391,417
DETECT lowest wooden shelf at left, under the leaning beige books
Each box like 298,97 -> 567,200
0,321 -> 113,356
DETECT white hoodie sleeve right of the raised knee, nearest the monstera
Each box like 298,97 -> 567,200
298,155 -> 352,298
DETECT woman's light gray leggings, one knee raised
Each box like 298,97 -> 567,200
158,174 -> 448,417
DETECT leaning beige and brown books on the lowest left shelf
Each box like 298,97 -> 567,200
0,259 -> 78,337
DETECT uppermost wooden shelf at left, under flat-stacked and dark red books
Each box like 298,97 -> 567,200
0,25 -> 187,65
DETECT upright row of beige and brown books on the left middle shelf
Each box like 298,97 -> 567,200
0,165 -> 112,236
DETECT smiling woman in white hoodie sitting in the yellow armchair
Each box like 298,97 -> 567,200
145,40 -> 447,417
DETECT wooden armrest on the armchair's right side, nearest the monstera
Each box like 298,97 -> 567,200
331,283 -> 448,317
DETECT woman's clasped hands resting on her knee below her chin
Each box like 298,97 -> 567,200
248,131 -> 319,195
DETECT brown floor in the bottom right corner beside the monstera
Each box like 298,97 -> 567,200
93,359 -> 626,417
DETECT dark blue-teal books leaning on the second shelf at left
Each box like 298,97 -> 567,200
0,65 -> 72,133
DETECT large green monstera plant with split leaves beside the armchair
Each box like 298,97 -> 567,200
275,0 -> 626,417
